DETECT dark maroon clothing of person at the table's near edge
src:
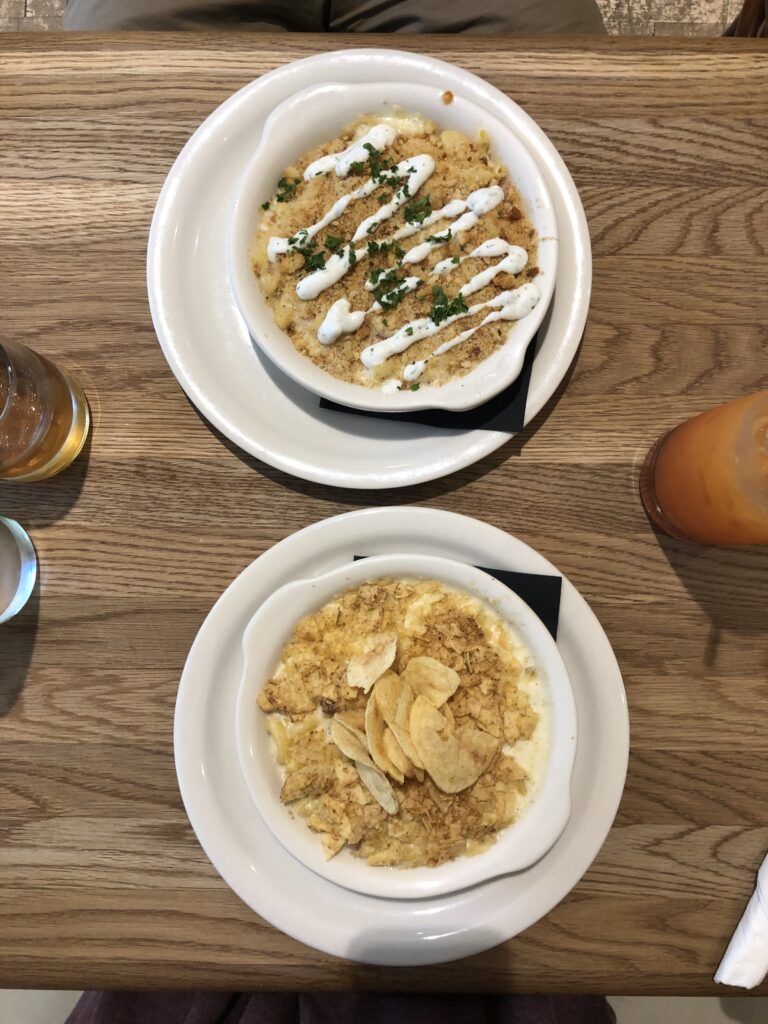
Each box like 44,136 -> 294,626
66,992 -> 616,1024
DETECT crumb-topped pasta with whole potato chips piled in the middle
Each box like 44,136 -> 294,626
258,580 -> 538,867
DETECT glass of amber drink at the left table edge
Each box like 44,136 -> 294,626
0,341 -> 90,483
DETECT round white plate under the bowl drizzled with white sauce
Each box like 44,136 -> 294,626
146,49 -> 592,487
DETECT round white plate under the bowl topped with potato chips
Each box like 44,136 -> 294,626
174,508 -> 629,966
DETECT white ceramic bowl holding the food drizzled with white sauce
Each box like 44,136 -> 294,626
226,82 -> 557,412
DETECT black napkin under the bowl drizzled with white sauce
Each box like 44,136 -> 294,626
319,335 -> 537,434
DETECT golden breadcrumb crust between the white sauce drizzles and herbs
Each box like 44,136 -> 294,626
251,117 -> 537,387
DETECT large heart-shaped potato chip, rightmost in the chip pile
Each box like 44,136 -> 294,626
411,694 -> 499,793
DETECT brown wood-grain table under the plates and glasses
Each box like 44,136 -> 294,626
0,29 -> 768,993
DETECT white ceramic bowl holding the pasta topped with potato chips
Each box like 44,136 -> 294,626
236,555 -> 577,899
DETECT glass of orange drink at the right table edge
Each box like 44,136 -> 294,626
640,391 -> 768,544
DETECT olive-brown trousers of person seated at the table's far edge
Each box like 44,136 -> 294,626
63,0 -> 605,35
